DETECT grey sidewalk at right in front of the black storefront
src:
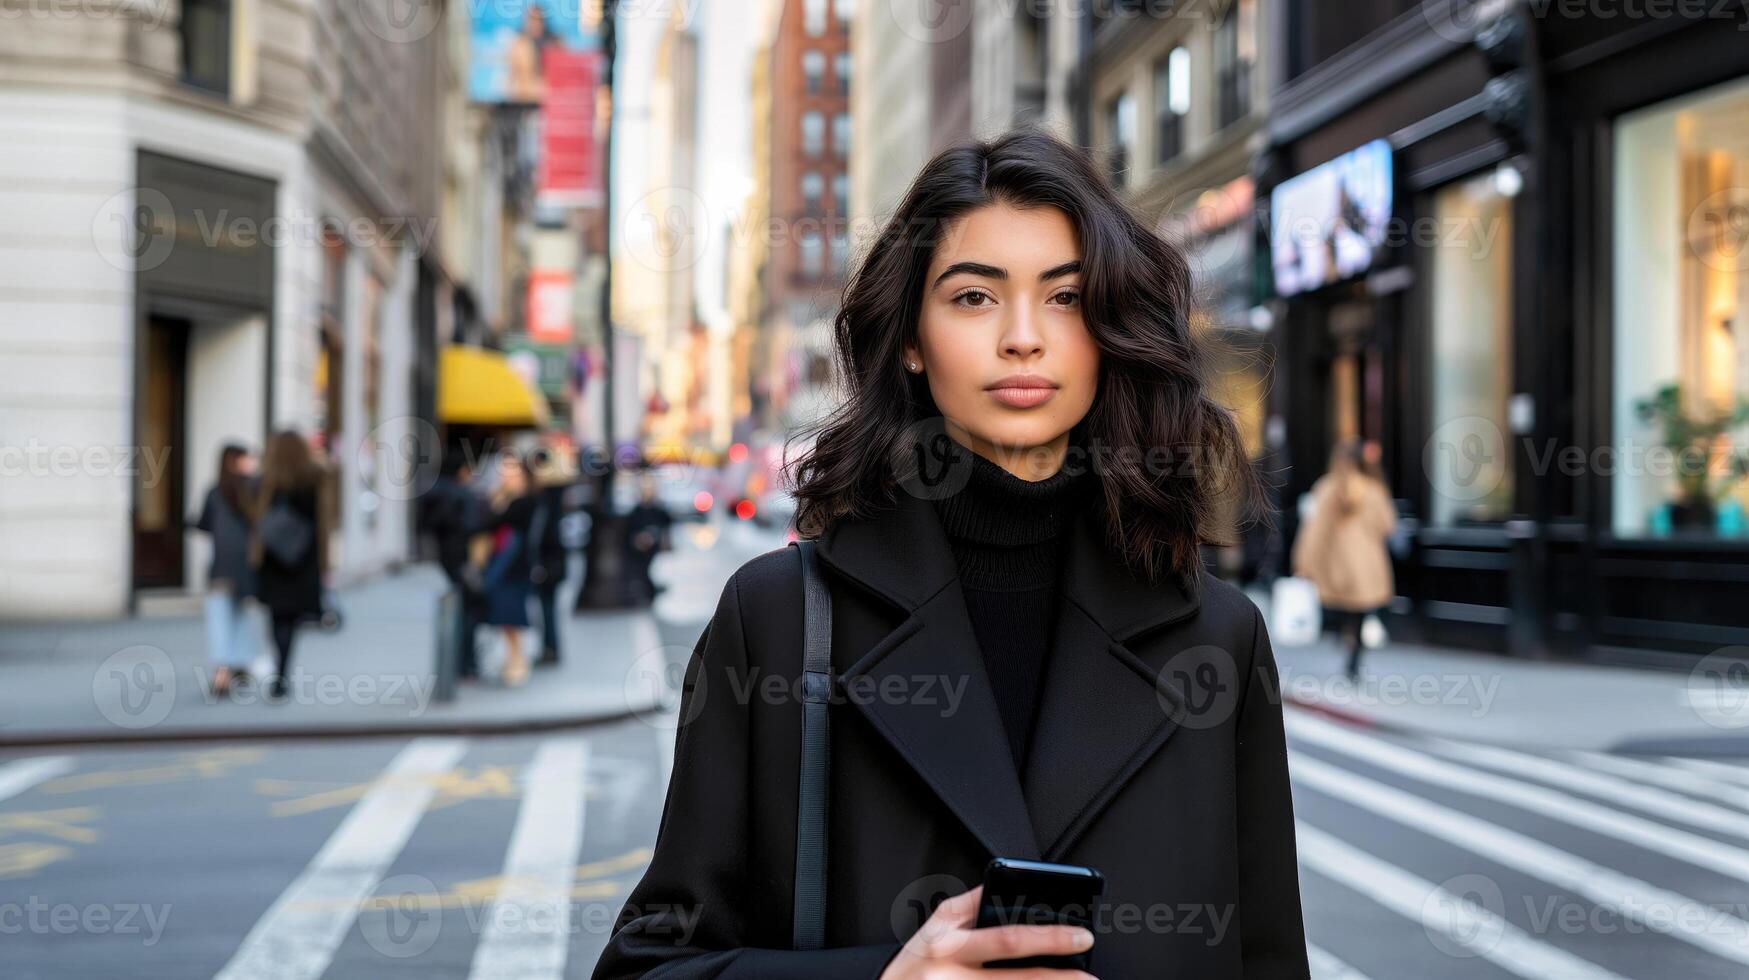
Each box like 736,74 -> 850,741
1275,616 -> 1749,756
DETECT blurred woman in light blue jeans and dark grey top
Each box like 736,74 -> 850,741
194,445 -> 255,697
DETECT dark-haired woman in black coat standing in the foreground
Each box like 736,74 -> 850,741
595,131 -> 1308,980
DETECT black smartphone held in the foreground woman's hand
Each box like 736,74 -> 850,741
978,858 -> 1105,970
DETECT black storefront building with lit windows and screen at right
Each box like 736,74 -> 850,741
1256,0 -> 1749,663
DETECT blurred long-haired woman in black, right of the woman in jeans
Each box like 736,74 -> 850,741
250,431 -> 331,700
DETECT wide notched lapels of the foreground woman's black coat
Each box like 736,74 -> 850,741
819,492 -> 1196,859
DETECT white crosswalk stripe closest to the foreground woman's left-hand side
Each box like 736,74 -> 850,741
469,737 -> 589,980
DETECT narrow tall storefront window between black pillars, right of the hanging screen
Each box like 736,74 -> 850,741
1425,172 -> 1513,527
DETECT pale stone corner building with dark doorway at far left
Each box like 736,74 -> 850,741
0,0 -> 444,618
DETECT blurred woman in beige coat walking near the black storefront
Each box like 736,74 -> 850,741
1293,439 -> 1397,679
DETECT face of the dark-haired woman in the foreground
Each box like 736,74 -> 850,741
904,203 -> 1098,480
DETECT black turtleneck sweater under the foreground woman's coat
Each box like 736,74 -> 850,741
936,448 -> 1088,774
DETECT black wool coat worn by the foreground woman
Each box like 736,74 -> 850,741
595,494 -> 1308,980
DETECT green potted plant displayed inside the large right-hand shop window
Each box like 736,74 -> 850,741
1634,382 -> 1749,530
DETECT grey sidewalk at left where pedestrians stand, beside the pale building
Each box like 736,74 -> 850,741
0,565 -> 696,746
